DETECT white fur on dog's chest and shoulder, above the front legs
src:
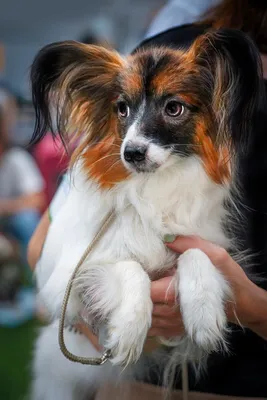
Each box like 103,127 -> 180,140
39,157 -> 232,286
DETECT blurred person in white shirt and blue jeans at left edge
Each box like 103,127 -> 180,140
0,90 -> 45,260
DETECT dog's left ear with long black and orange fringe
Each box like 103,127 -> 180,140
31,41 -> 124,147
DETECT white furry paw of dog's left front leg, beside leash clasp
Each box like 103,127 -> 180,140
105,298 -> 152,366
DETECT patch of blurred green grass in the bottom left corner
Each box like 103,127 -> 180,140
0,320 -> 39,400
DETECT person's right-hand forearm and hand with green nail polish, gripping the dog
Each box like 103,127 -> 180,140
150,237 -> 267,339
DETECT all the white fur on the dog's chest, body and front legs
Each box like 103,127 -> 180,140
33,130 -> 233,400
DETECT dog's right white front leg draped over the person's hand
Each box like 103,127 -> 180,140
177,249 -> 230,352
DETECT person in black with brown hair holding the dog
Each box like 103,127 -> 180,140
28,0 -> 267,398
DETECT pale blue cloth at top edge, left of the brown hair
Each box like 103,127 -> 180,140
145,0 -> 219,38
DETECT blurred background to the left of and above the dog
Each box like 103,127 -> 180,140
0,0 -> 164,400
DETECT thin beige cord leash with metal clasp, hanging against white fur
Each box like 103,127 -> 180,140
58,210 -> 189,400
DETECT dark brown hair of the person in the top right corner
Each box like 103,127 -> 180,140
200,0 -> 267,53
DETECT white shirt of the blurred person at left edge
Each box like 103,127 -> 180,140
0,148 -> 44,199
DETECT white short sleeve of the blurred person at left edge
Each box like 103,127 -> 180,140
9,149 -> 45,195
